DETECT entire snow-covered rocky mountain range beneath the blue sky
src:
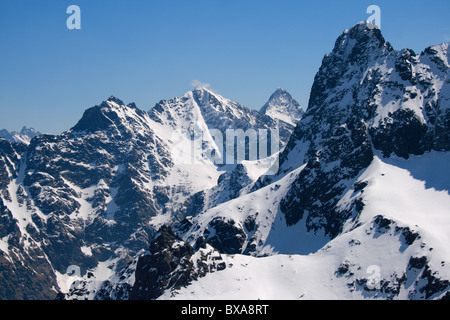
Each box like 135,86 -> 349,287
0,22 -> 450,300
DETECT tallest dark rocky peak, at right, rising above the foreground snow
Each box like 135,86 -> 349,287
255,23 -> 450,211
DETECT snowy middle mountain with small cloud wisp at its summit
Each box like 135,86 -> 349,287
149,87 -> 301,217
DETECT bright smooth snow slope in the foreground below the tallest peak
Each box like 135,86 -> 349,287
160,152 -> 450,299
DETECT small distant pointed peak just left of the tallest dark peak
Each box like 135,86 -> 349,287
260,88 -> 304,127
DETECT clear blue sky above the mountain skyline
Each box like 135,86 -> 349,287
0,0 -> 450,134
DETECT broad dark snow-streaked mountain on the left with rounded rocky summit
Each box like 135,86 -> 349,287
2,97 -> 178,298
